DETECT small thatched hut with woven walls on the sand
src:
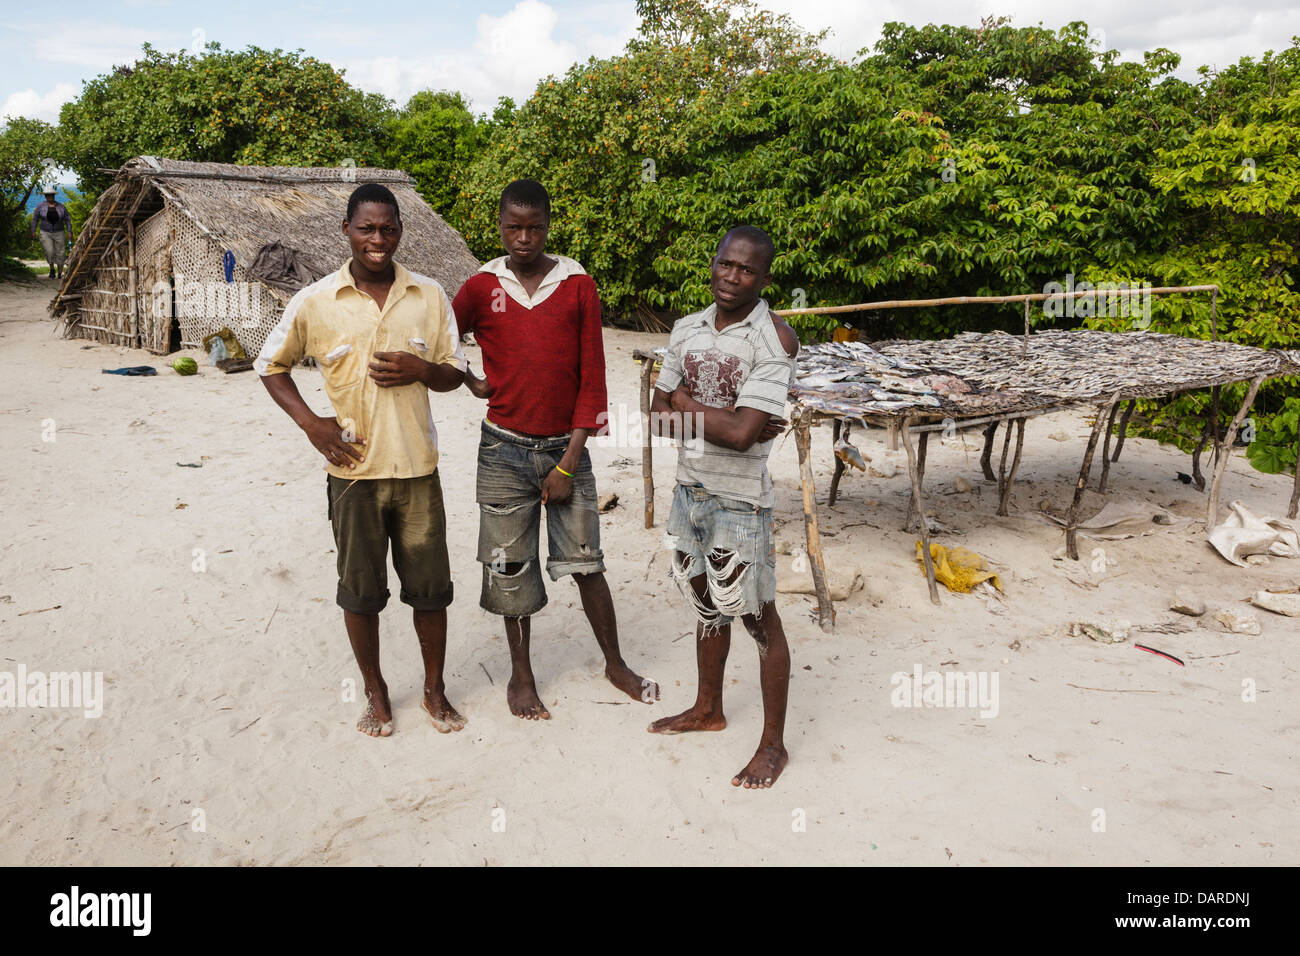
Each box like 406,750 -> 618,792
49,156 -> 478,355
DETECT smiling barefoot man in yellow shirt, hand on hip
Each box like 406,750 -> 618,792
255,183 -> 465,736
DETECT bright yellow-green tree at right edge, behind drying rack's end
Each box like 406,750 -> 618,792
1093,38 -> 1300,472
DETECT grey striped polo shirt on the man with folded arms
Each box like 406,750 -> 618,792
655,299 -> 794,507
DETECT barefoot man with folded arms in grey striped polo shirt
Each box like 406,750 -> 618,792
650,226 -> 800,790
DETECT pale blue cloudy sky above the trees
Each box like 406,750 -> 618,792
0,0 -> 1300,122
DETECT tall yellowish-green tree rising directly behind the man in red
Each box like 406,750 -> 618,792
454,0 -> 827,312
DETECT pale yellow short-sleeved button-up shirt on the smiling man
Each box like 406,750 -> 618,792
254,259 -> 465,479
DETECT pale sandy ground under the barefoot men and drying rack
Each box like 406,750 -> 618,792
0,282 -> 1300,865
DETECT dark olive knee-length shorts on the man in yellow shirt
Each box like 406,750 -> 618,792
325,470 -> 451,614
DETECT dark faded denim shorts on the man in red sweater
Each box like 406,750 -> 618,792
476,421 -> 605,618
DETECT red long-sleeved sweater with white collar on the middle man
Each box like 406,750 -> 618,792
451,272 -> 608,434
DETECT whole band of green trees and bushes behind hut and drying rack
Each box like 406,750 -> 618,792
0,0 -> 1300,471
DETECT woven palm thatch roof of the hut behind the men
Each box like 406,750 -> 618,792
49,156 -> 480,320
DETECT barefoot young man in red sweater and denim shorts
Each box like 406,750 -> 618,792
452,179 -> 659,721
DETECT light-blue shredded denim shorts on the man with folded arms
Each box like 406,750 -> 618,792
664,484 -> 776,630
